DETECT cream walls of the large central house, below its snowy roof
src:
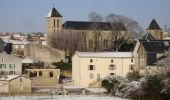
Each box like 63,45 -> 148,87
72,54 -> 134,87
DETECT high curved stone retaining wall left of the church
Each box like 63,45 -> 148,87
24,43 -> 65,63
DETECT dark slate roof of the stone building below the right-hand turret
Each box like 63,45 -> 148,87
140,40 -> 170,53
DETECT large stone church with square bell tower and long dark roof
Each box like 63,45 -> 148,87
46,8 -> 130,54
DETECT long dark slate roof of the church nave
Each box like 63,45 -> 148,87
62,21 -> 127,31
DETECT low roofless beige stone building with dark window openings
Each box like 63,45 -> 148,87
26,69 -> 60,86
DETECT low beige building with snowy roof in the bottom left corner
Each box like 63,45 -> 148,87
0,75 -> 32,93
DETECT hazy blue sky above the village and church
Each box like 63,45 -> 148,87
0,0 -> 170,33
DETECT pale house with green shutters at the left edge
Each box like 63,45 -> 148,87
0,52 -> 22,75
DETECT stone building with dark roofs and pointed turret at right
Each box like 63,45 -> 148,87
133,19 -> 170,75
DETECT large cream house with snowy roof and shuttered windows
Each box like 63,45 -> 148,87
72,52 -> 134,87
